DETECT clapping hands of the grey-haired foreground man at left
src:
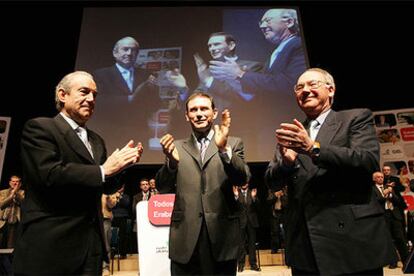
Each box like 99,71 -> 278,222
102,140 -> 143,176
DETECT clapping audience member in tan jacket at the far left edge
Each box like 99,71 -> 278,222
0,175 -> 24,248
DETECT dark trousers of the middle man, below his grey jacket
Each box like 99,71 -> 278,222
171,221 -> 237,276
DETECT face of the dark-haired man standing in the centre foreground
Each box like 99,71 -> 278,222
185,96 -> 217,133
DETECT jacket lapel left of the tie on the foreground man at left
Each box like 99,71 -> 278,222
54,114 -> 95,163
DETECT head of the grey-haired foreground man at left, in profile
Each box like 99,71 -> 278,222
55,71 -> 97,126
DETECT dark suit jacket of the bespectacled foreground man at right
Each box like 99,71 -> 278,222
266,109 -> 396,275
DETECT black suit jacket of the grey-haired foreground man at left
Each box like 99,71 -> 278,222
14,115 -> 116,275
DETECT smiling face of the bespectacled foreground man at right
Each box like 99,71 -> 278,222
295,71 -> 335,117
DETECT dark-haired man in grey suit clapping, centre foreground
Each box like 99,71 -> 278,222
156,92 -> 248,275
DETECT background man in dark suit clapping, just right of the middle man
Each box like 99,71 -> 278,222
234,183 -> 260,272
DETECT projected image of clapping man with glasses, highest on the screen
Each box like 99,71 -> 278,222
210,9 -> 306,102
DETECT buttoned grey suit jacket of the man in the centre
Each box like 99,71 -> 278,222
156,136 -> 247,264
